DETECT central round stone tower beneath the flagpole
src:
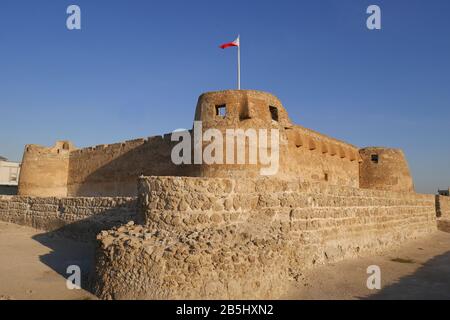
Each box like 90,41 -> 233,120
194,90 -> 292,178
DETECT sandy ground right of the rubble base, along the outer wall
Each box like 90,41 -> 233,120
287,231 -> 450,300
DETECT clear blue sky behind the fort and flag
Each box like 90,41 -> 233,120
0,0 -> 450,193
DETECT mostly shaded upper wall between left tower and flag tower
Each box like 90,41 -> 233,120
68,135 -> 198,197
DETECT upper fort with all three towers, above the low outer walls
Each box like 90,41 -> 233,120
19,90 -> 413,196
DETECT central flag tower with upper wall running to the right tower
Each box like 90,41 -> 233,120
195,90 -> 359,187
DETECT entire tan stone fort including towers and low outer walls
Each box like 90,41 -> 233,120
0,90 -> 450,299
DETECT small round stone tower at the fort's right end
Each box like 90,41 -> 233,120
359,147 -> 414,192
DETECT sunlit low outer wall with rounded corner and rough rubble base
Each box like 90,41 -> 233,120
94,177 -> 436,299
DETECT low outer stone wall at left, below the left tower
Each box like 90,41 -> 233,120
0,196 -> 136,241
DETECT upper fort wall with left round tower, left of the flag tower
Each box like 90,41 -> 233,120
19,135 -> 198,197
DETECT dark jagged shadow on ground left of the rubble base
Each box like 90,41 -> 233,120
33,208 -> 137,293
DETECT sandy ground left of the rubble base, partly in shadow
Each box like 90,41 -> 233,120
0,222 -> 96,300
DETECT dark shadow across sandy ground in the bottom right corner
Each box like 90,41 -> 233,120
359,251 -> 450,300
